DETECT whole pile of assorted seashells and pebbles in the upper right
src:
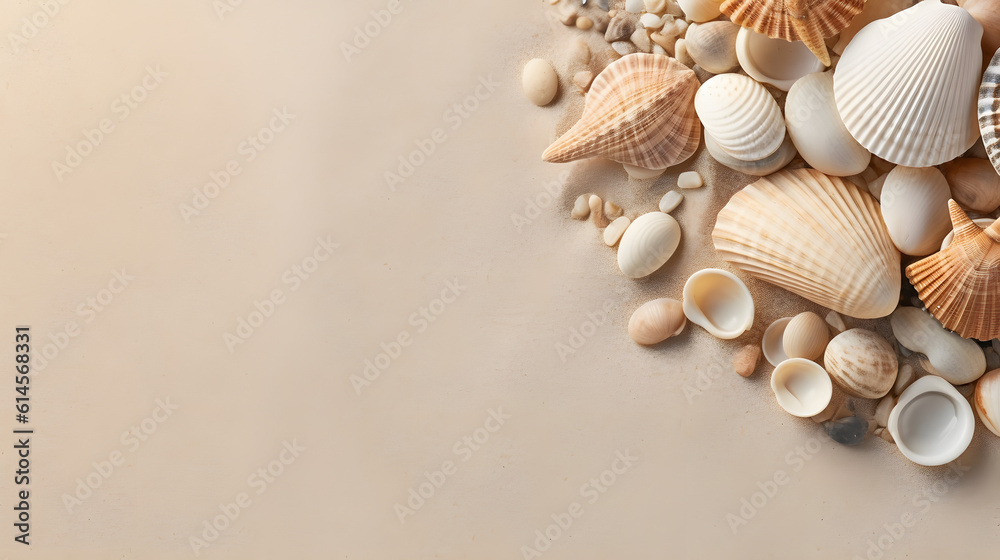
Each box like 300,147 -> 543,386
522,0 -> 1000,466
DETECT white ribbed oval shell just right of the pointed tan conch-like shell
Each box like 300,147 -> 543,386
694,74 -> 785,161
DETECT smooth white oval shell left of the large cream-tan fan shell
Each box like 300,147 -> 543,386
618,212 -> 681,278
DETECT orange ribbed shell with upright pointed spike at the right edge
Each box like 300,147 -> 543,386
906,200 -> 1000,342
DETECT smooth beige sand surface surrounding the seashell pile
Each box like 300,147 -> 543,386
0,0 -> 1000,560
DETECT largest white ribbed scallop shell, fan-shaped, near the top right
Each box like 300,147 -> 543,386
833,0 -> 983,167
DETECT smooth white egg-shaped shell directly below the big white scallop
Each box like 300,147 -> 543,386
880,165 -> 952,257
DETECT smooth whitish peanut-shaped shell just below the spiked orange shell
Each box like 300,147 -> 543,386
889,307 -> 986,385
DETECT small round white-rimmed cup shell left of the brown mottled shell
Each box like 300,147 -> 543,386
771,358 -> 833,418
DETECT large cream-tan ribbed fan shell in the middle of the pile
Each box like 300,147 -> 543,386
712,169 -> 900,319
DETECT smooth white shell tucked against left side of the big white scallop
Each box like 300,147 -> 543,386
785,72 -> 871,177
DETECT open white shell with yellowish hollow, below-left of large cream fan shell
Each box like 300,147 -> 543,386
684,268 -> 754,340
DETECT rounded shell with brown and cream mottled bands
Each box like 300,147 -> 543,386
823,329 -> 899,399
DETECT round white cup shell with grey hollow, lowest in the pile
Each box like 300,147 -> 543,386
888,375 -> 976,467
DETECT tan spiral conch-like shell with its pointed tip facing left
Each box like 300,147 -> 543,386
542,53 -> 701,169
